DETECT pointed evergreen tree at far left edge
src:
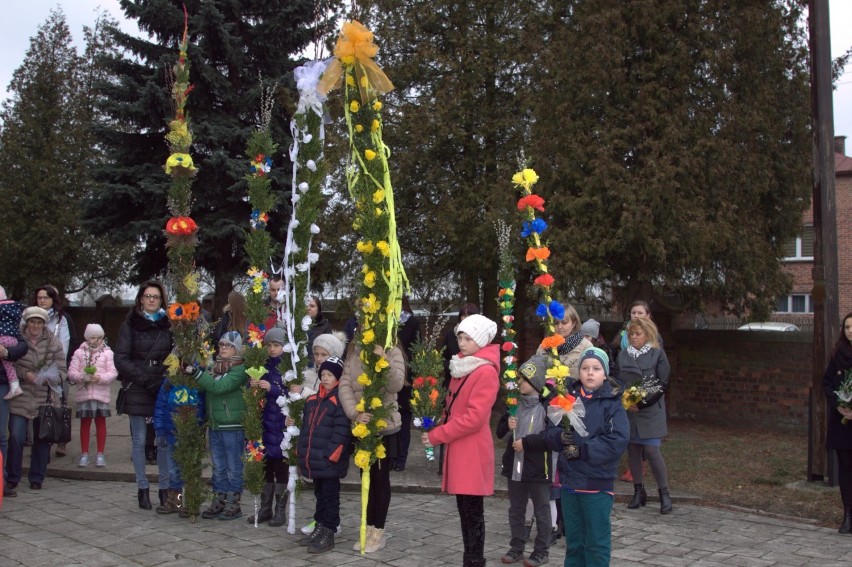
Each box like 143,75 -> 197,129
0,9 -> 133,298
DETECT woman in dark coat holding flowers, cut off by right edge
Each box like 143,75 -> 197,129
822,313 -> 852,534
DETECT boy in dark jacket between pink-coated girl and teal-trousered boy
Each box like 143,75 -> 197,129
497,355 -> 554,567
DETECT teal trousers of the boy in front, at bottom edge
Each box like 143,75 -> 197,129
562,490 -> 612,567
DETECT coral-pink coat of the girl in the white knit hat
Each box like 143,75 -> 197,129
429,344 -> 500,496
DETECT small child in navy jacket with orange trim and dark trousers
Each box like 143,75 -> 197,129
297,356 -> 352,553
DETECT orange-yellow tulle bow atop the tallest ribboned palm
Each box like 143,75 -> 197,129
317,20 -> 393,104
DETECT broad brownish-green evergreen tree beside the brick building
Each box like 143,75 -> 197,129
531,0 -> 811,313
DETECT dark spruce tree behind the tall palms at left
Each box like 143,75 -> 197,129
87,0 -> 340,306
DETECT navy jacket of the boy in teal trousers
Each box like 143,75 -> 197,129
523,381 -> 630,492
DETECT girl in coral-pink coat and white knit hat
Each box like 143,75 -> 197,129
422,315 -> 500,567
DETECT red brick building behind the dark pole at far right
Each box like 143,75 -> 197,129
776,136 -> 852,315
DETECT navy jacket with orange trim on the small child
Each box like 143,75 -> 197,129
297,386 -> 352,478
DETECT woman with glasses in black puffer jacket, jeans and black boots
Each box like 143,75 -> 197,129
115,281 -> 172,510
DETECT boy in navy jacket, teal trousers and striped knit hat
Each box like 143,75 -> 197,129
514,347 -> 630,567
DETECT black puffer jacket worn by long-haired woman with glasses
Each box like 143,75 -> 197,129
115,309 -> 172,417
